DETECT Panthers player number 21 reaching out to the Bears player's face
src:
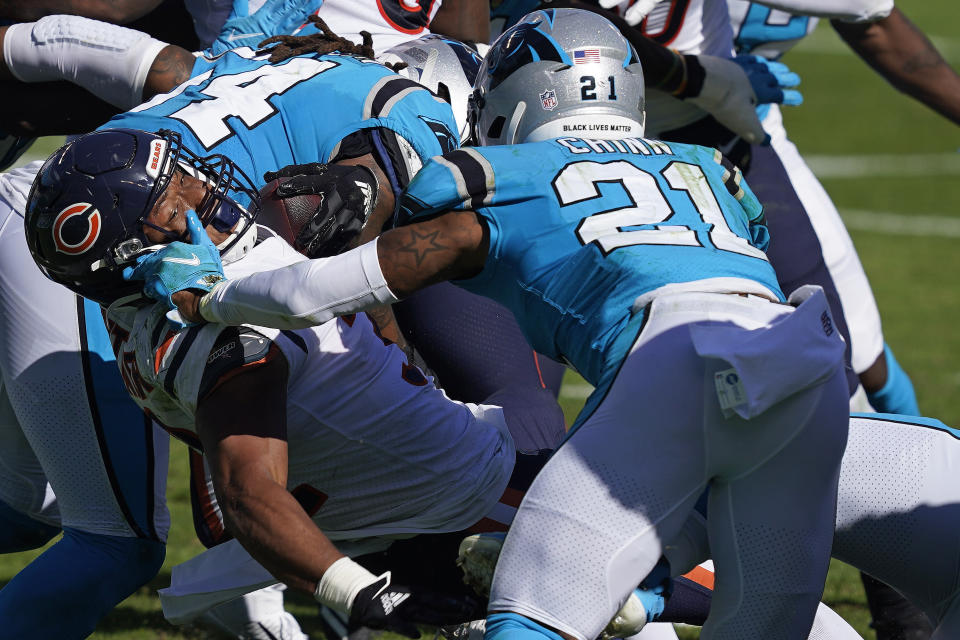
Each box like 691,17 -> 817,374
134,9 -> 846,640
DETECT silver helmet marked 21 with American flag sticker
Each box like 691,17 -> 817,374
470,9 -> 645,145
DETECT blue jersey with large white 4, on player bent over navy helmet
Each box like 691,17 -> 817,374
100,47 -> 459,205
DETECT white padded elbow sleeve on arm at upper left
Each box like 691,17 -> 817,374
3,15 -> 167,109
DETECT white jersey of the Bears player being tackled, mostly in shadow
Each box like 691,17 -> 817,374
108,238 -> 515,540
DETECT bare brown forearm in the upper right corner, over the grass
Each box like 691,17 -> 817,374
833,9 -> 960,124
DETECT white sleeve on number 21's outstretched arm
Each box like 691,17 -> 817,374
200,240 -> 397,329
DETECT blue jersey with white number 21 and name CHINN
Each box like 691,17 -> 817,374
397,137 -> 783,385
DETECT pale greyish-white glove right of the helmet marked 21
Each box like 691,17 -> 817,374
685,55 -> 769,144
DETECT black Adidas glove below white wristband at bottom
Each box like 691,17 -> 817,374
350,571 -> 485,638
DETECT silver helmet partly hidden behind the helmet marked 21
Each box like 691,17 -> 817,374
377,35 -> 481,142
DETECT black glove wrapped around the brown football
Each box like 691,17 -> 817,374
264,162 -> 379,258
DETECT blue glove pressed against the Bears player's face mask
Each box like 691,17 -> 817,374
123,209 -> 225,309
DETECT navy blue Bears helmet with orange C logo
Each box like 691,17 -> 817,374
24,129 -> 260,305
